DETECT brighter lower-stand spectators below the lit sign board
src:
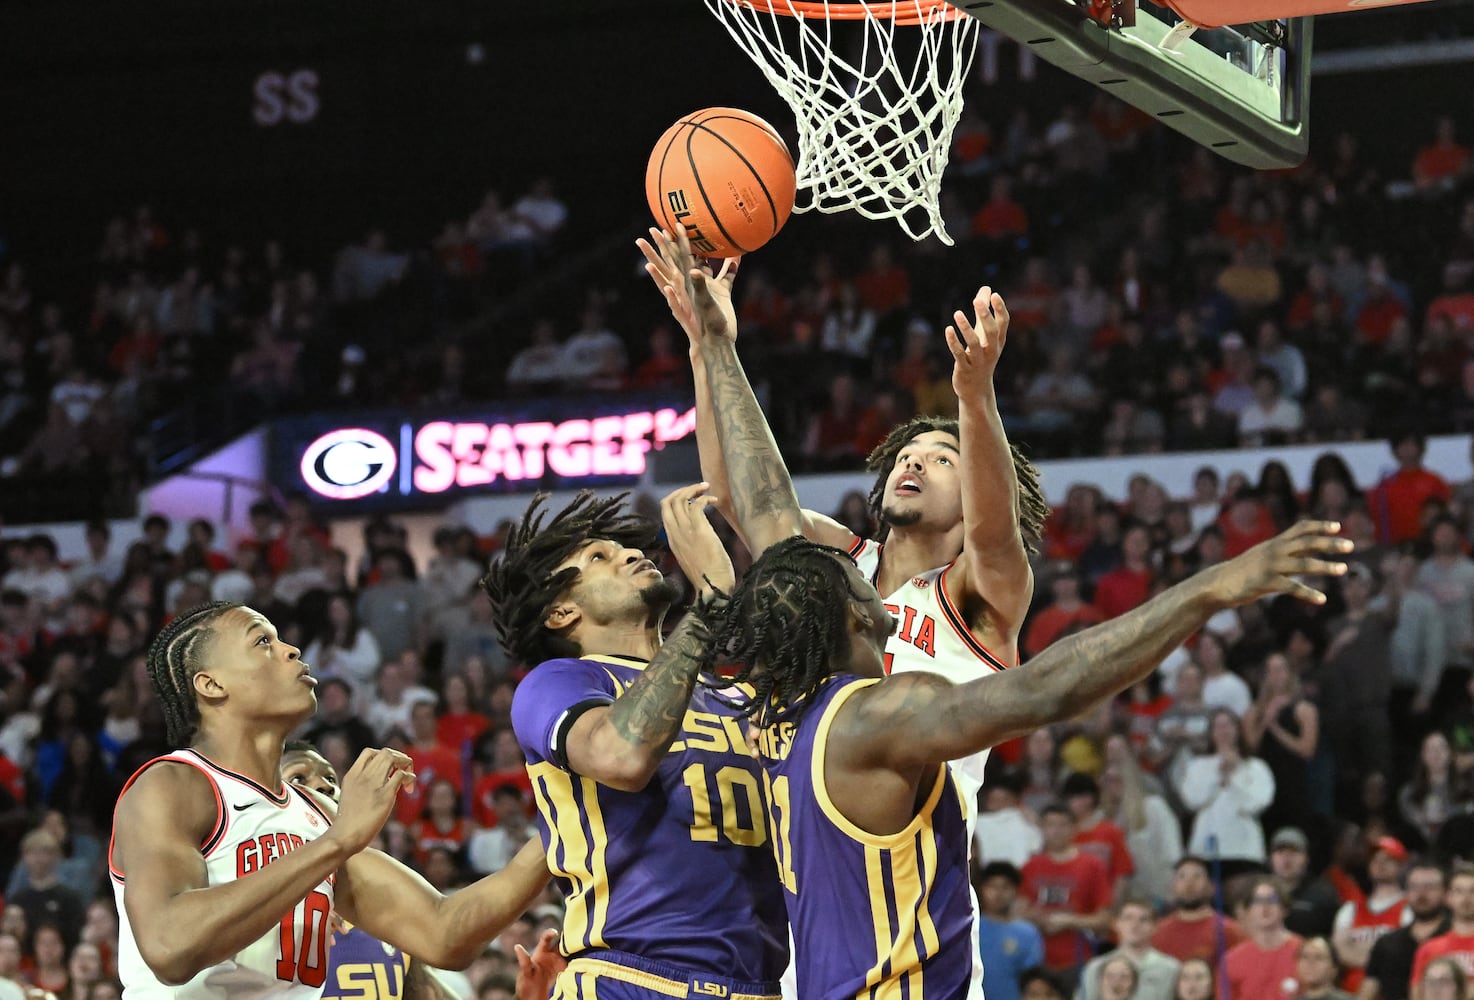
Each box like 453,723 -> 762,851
0,434 -> 1474,1000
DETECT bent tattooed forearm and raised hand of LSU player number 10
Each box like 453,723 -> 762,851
560,482 -> 736,796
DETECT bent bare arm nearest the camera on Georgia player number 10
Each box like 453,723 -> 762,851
113,751 -> 414,985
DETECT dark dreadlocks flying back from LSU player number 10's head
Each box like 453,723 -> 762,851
481,490 -> 659,667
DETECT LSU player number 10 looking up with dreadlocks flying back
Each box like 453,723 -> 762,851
485,484 -> 787,1000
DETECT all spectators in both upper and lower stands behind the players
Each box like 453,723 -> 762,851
0,35 -> 1474,1000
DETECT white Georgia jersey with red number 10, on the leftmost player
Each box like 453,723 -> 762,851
108,749 -> 335,1000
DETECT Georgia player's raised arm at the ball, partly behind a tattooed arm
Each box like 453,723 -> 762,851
635,229 -> 855,550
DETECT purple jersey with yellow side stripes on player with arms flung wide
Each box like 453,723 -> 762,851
759,674 -> 973,1000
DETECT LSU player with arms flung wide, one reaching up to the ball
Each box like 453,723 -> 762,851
681,227 -> 1352,1000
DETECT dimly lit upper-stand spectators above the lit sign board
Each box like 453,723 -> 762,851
0,69 -> 1474,513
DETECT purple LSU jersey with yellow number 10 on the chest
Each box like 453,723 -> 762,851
511,656 -> 789,982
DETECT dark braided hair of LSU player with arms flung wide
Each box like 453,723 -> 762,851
700,535 -> 861,726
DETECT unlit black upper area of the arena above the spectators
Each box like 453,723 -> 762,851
0,0 -> 1468,293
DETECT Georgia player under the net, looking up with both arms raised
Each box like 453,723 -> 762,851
638,230 -> 1048,1000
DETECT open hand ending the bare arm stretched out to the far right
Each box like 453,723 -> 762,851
1207,521 -> 1355,606
